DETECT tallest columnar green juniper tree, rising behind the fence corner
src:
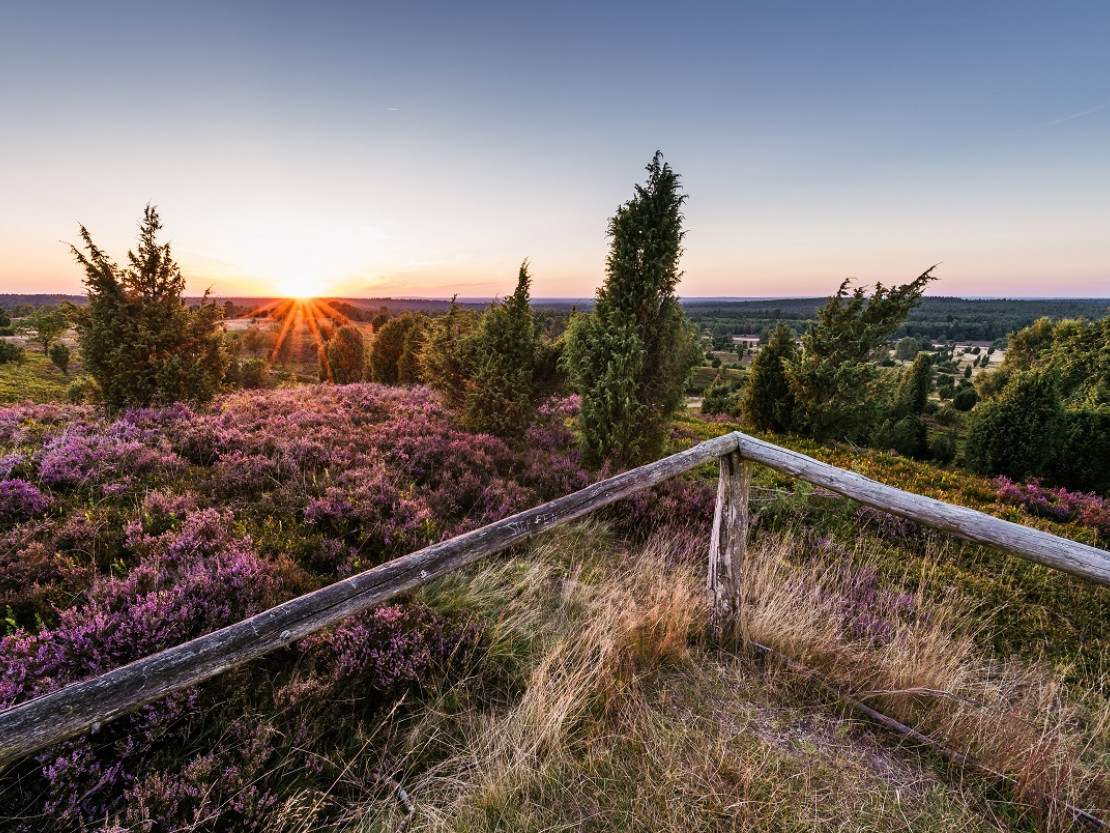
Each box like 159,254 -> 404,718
564,152 -> 698,466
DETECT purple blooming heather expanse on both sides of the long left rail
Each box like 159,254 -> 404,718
0,384 -> 713,831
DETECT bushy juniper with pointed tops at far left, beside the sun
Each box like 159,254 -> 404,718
70,205 -> 230,411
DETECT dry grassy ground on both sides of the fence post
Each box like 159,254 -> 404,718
257,522 -> 1110,833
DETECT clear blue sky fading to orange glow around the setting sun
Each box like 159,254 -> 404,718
0,0 -> 1110,298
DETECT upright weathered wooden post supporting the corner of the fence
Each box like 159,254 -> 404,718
708,451 -> 751,636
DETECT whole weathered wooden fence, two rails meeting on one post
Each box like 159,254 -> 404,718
0,432 -> 1110,765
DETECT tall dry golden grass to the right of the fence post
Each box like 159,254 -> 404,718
741,536 -> 1108,823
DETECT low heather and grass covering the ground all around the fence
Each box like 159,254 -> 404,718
0,384 -> 1110,830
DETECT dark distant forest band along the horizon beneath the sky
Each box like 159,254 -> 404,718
0,293 -> 1110,342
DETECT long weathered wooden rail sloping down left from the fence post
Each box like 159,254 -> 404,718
0,434 -> 737,765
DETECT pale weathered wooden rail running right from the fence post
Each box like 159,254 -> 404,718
735,432 -> 1110,585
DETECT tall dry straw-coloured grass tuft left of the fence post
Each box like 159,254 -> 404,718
350,523 -> 706,830
